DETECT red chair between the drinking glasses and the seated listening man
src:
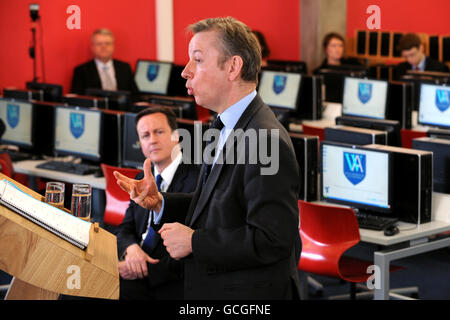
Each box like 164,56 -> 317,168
101,163 -> 140,226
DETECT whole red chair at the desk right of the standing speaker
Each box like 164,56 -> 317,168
298,200 -> 415,299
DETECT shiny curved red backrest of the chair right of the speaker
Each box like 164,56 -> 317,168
298,200 -> 360,277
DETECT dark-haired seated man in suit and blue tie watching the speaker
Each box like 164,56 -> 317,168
117,107 -> 199,299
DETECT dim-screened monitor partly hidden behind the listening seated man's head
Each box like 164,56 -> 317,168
122,112 -> 145,168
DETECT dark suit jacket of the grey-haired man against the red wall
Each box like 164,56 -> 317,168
70,59 -> 138,95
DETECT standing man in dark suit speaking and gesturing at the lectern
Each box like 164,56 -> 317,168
115,18 -> 301,300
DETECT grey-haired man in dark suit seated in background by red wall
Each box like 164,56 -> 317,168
71,29 -> 137,95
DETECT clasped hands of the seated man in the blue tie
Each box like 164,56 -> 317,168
119,244 -> 159,279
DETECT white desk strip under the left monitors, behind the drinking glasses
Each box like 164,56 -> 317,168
13,160 -> 106,190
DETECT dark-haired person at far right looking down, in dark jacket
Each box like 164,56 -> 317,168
394,33 -> 449,80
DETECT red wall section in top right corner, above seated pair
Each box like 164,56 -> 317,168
347,0 -> 450,37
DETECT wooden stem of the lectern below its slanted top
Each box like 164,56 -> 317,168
5,277 -> 59,300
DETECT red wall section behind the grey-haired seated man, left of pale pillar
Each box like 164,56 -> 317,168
0,0 -> 156,92
